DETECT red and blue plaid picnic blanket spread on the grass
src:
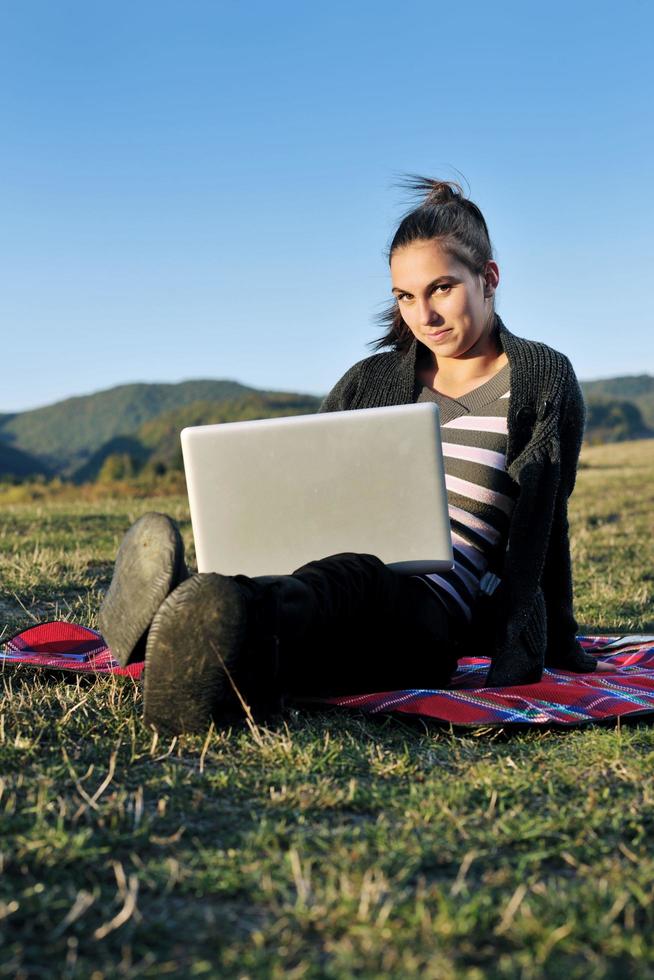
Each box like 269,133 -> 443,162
0,622 -> 654,726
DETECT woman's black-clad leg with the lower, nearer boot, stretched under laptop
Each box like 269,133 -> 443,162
144,554 -> 456,732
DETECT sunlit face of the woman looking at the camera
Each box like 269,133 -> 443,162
391,240 -> 499,358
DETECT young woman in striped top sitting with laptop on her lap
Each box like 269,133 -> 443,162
100,178 -> 595,732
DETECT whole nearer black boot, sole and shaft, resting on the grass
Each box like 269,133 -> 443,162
144,573 -> 314,734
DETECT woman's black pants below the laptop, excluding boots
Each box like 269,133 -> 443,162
258,554 -> 456,696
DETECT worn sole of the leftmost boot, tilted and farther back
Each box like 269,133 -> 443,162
98,513 -> 188,667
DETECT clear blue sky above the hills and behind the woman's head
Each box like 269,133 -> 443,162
0,0 -> 654,412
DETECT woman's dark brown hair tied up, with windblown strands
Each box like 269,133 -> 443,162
371,175 -> 493,351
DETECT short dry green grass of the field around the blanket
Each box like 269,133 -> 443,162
0,442 -> 654,980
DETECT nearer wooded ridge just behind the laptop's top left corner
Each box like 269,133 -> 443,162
73,392 -> 320,483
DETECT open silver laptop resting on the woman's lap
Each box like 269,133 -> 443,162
181,403 -> 452,576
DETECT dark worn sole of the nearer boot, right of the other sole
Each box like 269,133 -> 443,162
144,573 -> 247,735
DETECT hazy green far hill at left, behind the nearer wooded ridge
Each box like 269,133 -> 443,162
0,380 -> 302,476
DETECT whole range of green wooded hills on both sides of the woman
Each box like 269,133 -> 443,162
0,374 -> 654,482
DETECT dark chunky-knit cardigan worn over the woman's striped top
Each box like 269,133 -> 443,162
320,317 -> 595,687
